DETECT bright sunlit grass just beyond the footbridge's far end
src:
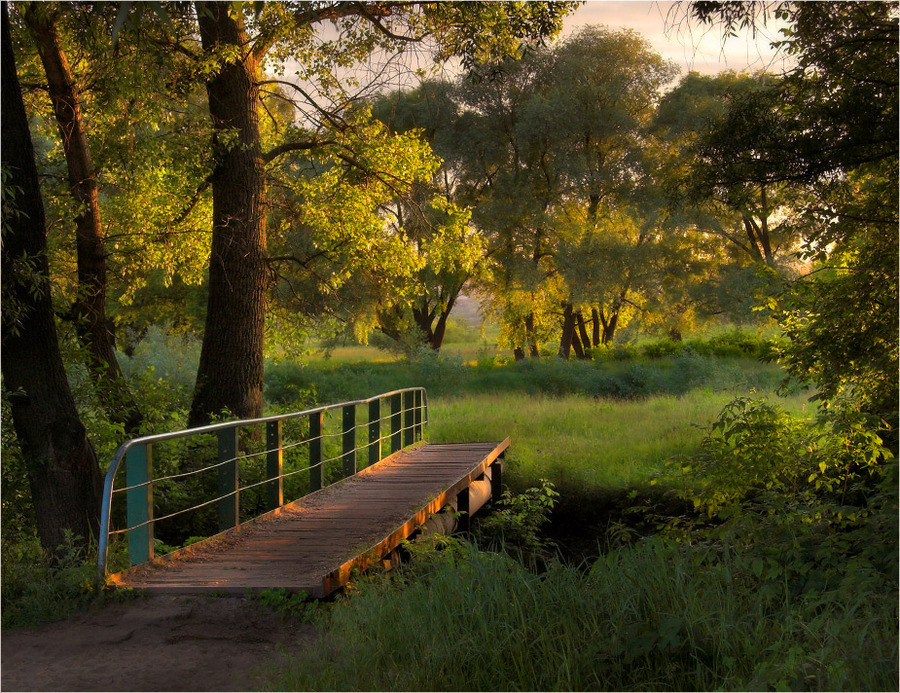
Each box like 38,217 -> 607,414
426,390 -> 806,490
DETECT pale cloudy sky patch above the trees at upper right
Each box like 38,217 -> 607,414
563,0 -> 782,74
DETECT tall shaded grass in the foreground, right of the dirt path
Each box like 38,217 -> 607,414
269,539 -> 897,691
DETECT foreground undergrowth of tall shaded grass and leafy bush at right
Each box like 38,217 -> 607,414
270,392 -> 898,690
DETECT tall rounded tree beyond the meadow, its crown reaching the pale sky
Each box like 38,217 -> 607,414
450,28 -> 673,358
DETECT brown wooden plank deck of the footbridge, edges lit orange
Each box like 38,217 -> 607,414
109,438 -> 509,597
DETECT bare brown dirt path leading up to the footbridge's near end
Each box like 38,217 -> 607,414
0,596 -> 316,691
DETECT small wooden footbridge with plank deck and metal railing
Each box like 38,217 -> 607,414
98,388 -> 509,597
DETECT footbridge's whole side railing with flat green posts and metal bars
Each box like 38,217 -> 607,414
97,387 -> 428,582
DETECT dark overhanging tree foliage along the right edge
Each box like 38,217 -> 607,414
690,2 -> 900,424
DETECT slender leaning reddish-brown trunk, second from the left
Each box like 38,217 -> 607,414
24,2 -> 142,432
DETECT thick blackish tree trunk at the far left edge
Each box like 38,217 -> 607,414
0,3 -> 102,551
